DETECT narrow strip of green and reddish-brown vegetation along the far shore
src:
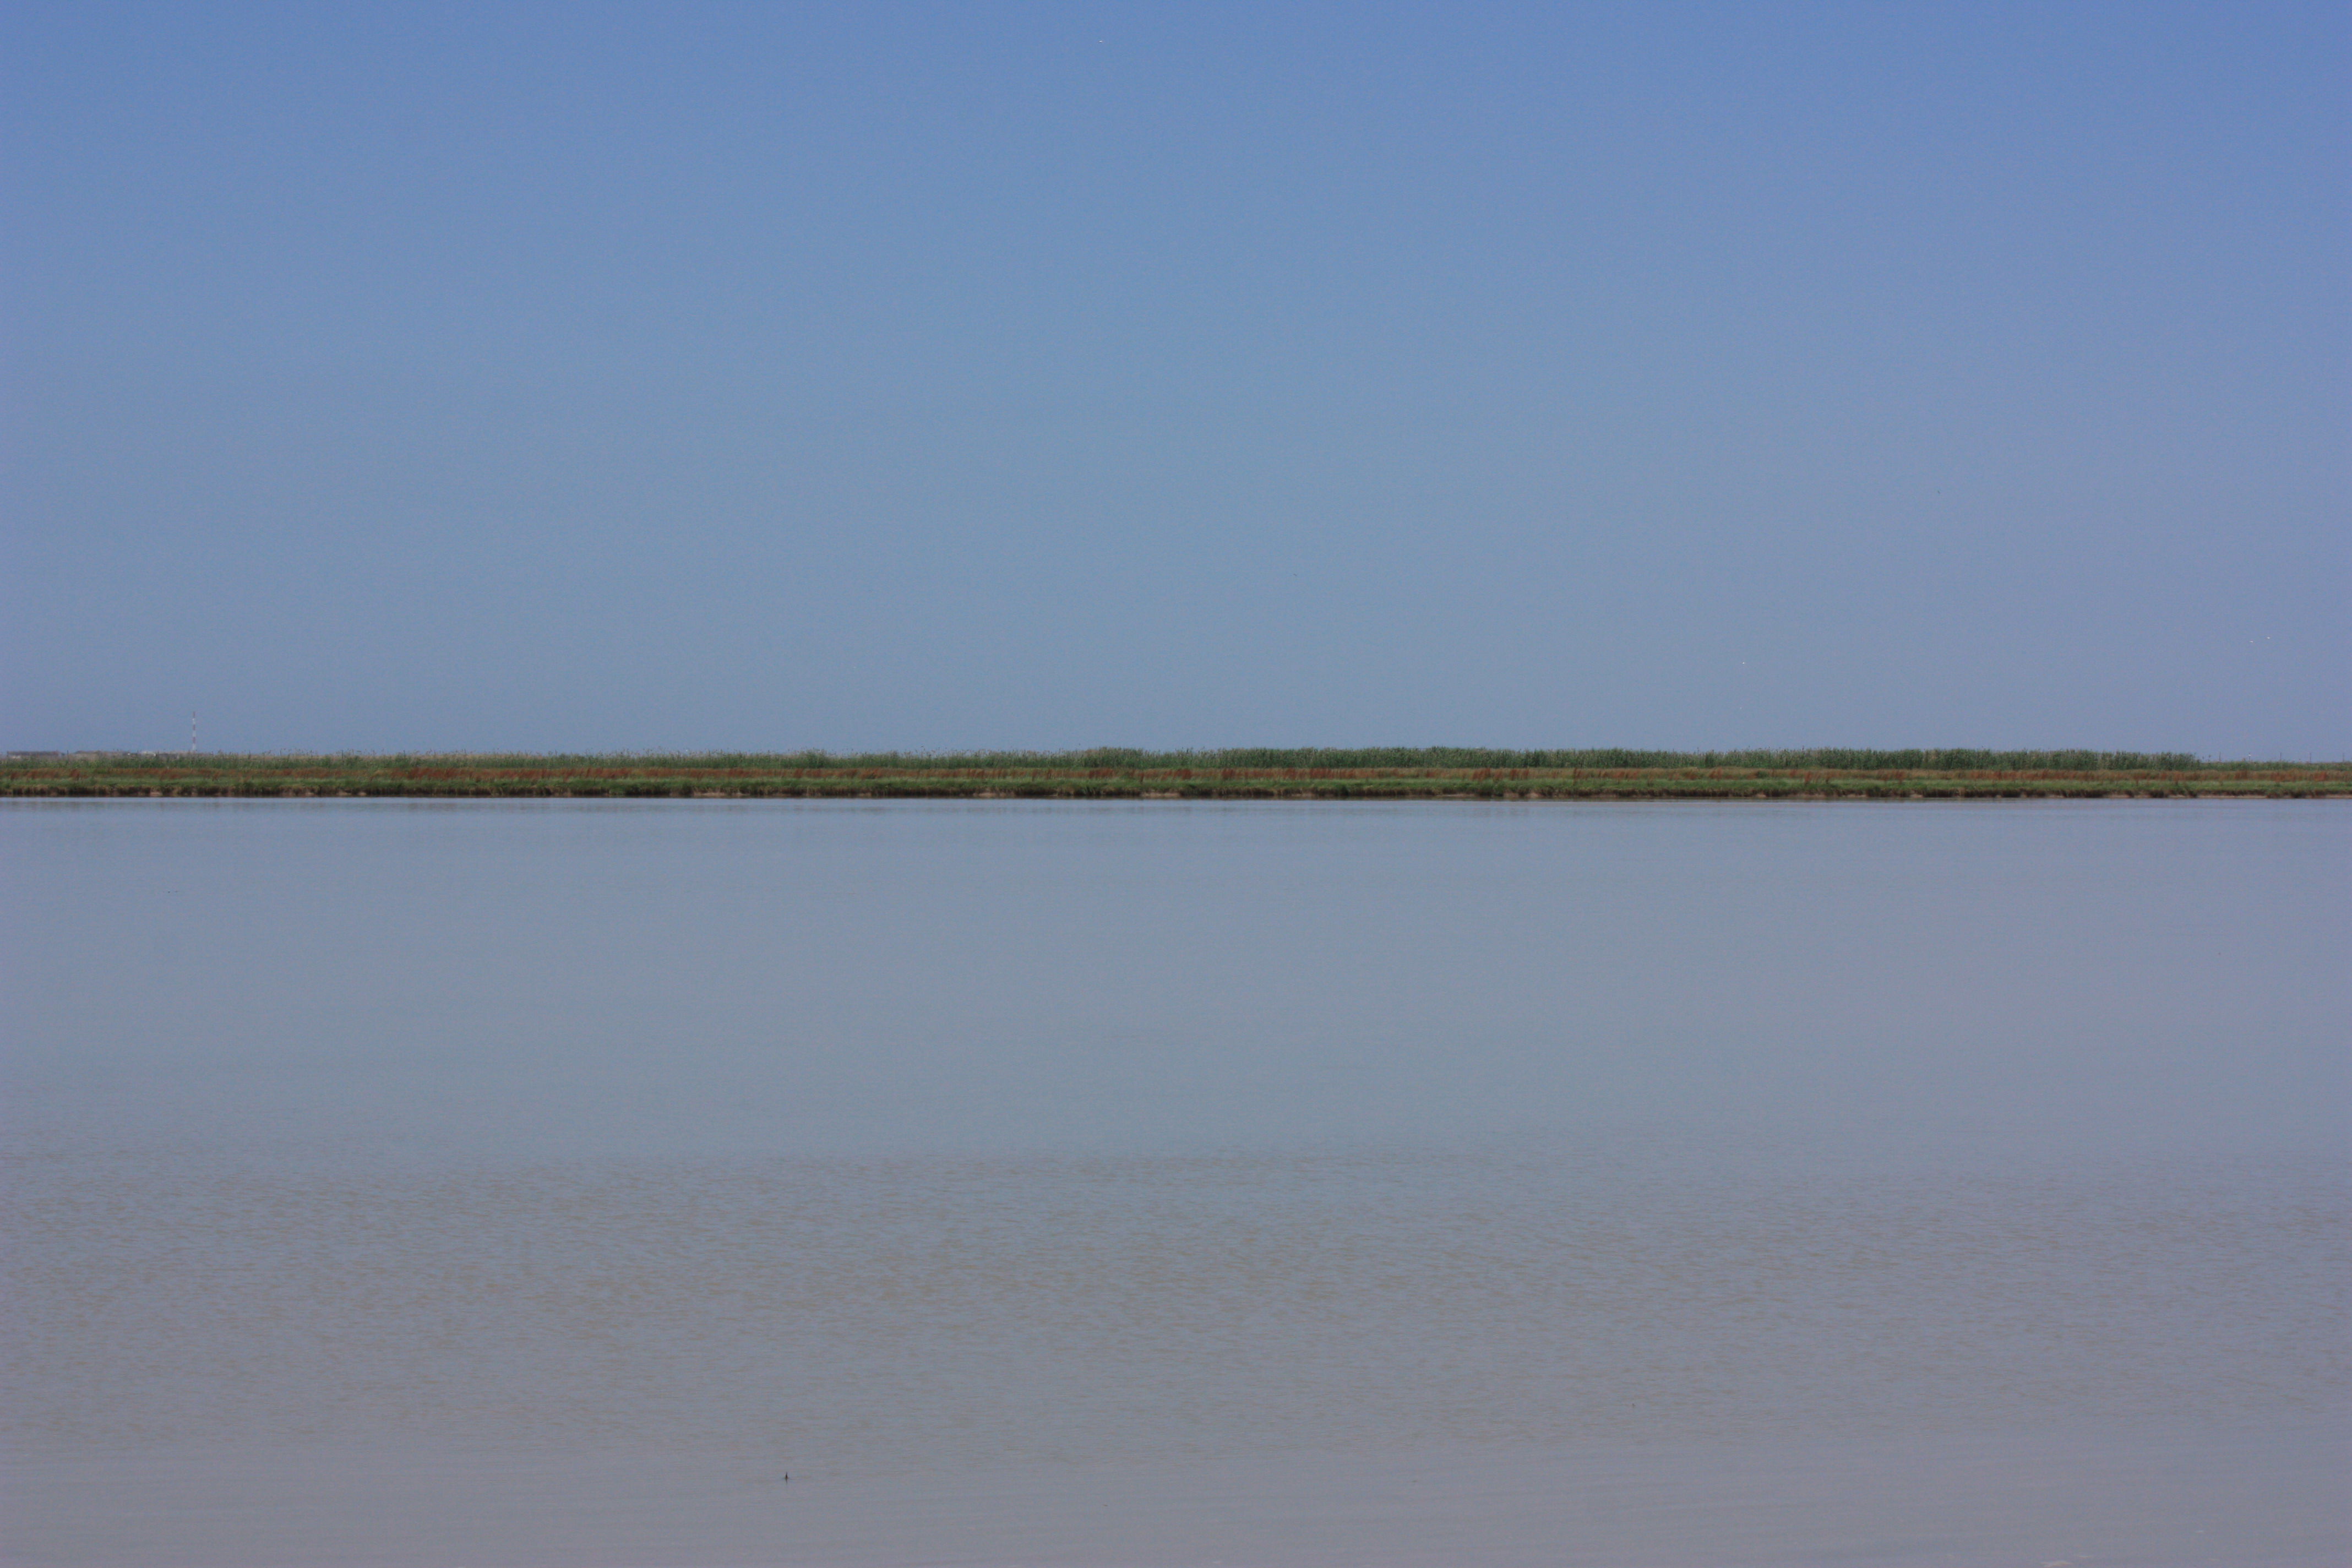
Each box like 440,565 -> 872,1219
0,745 -> 2352,799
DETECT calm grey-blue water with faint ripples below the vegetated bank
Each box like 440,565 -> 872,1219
0,802 -> 2352,1568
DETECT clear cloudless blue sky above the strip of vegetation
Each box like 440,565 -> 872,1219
0,0 -> 2352,757
